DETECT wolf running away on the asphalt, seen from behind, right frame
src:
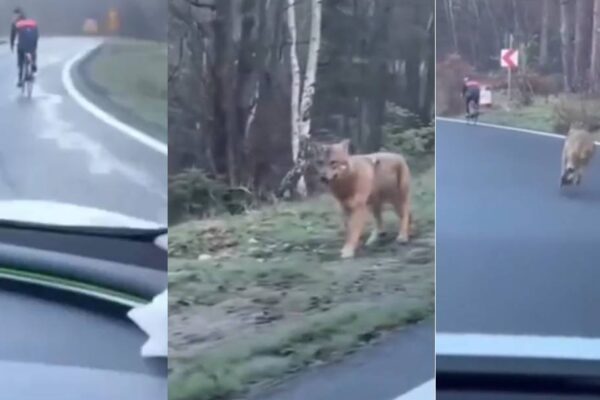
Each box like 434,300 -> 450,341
560,125 -> 596,186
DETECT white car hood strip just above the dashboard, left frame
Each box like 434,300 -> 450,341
0,200 -> 164,229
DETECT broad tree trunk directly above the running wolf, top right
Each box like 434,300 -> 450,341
574,0 -> 594,92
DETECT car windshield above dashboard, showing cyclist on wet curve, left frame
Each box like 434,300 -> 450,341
0,0 -> 167,229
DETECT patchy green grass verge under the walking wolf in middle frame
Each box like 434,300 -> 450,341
169,161 -> 434,400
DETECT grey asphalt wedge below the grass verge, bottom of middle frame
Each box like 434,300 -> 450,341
252,321 -> 434,400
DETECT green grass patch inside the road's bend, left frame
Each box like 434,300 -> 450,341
89,39 -> 168,136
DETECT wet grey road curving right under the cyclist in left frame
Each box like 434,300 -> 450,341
0,38 -> 167,225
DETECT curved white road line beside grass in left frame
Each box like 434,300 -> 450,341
62,42 -> 168,156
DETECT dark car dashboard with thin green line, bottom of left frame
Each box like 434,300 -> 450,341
0,222 -> 167,400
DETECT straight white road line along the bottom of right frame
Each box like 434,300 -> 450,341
435,333 -> 600,361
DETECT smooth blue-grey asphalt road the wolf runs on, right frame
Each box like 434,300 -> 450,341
436,120 -> 600,338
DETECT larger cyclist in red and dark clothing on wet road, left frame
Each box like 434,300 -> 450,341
10,7 -> 39,87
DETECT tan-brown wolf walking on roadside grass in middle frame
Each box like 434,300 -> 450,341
320,140 -> 411,258
